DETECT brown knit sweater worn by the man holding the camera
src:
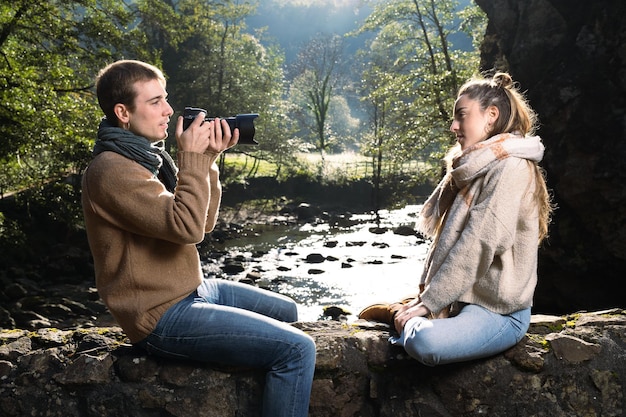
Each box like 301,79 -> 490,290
82,152 -> 221,343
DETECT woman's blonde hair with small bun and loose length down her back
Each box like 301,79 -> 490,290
457,72 -> 555,243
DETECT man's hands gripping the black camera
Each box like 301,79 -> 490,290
176,113 -> 239,155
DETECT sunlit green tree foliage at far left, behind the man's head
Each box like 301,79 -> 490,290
0,0 -> 154,192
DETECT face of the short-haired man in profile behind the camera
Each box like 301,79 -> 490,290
129,80 -> 174,142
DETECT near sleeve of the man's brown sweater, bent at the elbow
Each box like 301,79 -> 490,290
83,152 -> 213,244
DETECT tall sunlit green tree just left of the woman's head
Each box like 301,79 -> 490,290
358,0 -> 485,179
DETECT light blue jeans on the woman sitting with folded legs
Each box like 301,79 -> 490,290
390,304 -> 530,366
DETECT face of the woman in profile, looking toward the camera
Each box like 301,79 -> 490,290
450,95 -> 498,150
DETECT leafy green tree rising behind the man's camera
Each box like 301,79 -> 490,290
139,0 -> 297,176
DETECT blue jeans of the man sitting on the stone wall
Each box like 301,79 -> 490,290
138,279 -> 315,417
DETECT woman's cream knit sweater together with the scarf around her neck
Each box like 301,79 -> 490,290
421,134 -> 544,314
